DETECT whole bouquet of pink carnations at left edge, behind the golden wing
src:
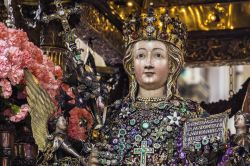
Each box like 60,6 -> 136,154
0,23 -> 62,122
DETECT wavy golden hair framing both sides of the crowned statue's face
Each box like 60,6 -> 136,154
123,40 -> 184,101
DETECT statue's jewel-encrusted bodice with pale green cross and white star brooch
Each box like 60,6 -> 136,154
103,96 -> 207,166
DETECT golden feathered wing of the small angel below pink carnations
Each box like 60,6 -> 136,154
24,70 -> 56,151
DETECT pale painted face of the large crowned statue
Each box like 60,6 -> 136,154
133,40 -> 169,90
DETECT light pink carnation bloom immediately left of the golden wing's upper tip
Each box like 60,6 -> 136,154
8,66 -> 24,85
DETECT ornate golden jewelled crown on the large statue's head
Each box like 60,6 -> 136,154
123,4 -> 187,50
